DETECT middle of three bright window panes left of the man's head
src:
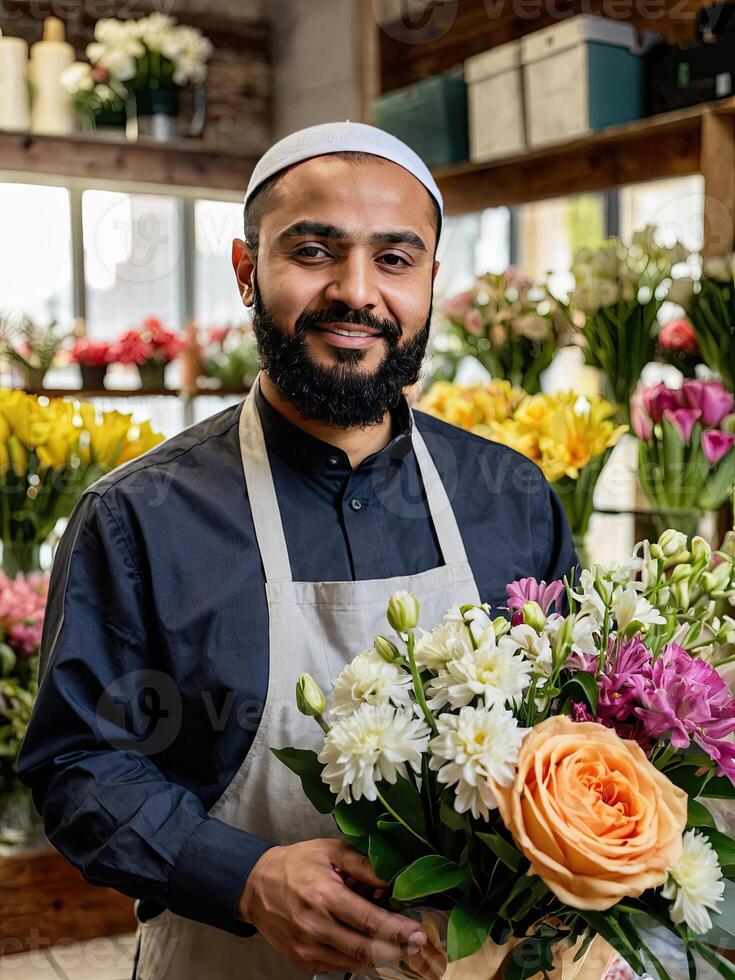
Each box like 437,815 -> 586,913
82,190 -> 184,338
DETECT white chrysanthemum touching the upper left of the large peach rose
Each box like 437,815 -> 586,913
429,704 -> 528,820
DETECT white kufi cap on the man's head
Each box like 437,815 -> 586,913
245,121 -> 444,212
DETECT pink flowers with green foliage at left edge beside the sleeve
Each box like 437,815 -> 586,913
0,572 -> 48,848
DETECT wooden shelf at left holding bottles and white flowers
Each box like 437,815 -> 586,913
0,131 -> 257,194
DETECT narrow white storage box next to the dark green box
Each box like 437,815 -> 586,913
464,41 -> 526,163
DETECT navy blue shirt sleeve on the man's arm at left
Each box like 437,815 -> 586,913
19,491 -> 272,935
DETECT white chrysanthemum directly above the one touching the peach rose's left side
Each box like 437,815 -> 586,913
426,630 -> 533,709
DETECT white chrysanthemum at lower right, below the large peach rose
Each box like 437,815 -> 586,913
662,830 -> 725,933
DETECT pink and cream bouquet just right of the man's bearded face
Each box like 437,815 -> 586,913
434,267 -> 567,393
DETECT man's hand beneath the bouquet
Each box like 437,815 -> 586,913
239,839 -> 426,973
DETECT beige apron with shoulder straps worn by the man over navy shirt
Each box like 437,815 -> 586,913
136,384 -> 480,980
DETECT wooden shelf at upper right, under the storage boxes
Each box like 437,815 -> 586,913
433,98 -> 735,214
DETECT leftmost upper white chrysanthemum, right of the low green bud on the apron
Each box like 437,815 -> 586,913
329,650 -> 412,718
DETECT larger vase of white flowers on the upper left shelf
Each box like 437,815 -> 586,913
87,13 -> 212,140
